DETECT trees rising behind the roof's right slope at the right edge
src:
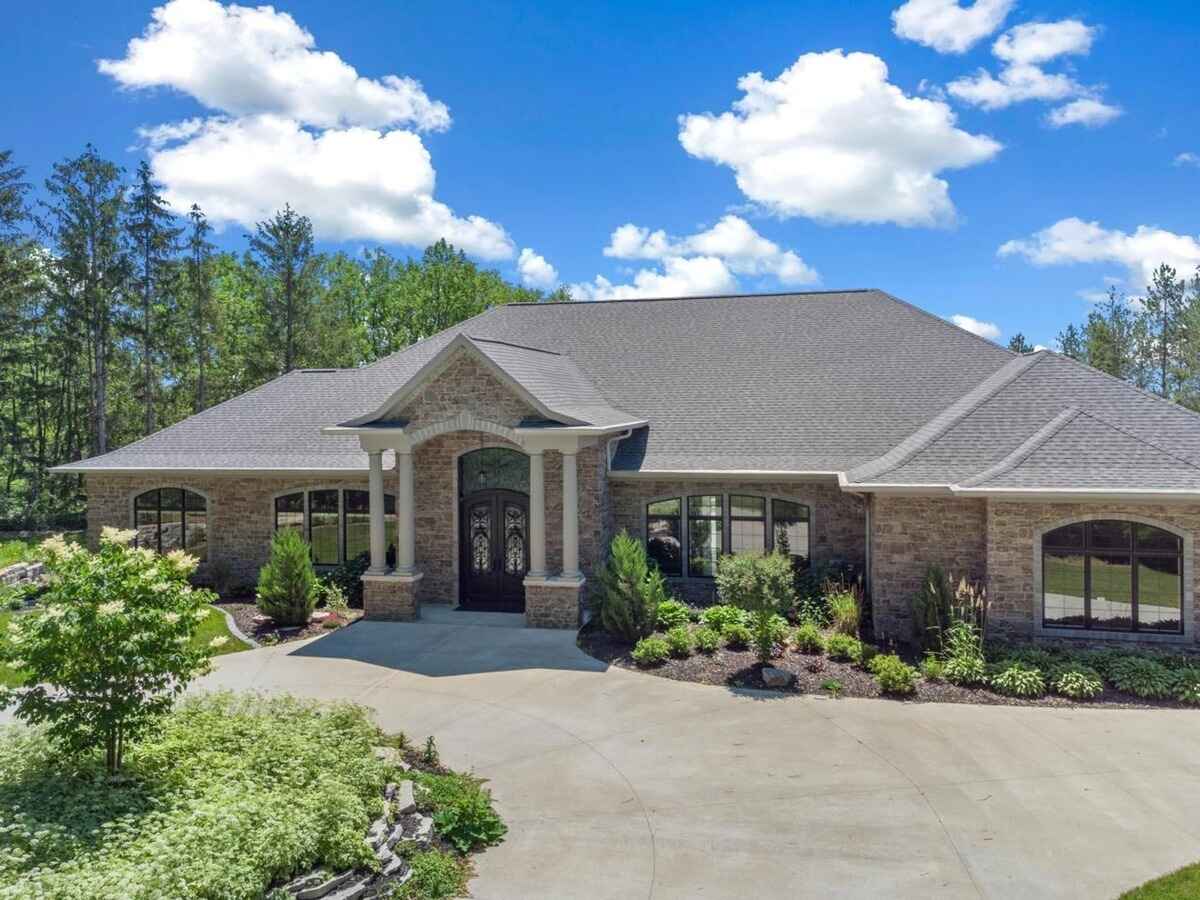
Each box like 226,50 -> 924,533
1008,263 -> 1200,410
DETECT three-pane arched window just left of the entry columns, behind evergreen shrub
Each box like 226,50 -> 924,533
275,488 -> 396,565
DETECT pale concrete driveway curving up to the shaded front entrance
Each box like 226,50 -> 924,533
196,611 -> 1200,900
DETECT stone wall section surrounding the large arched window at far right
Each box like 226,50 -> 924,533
988,500 -> 1200,643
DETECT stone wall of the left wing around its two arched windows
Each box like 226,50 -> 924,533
85,472 -> 372,584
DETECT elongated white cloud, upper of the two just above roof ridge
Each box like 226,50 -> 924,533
604,215 -> 820,284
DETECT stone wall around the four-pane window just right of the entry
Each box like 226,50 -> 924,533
608,478 -> 866,604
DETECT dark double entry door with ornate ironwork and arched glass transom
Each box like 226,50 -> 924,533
458,448 -> 529,612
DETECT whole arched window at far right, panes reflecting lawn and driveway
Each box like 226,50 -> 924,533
1042,520 -> 1183,634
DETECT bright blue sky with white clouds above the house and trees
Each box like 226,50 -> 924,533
0,0 -> 1200,346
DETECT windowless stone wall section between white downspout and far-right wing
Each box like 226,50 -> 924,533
871,494 -> 989,642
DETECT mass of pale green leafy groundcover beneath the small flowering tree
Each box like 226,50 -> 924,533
0,694 -> 394,900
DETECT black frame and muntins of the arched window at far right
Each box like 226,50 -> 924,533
1039,518 -> 1186,636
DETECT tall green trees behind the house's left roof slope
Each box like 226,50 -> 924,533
0,145 -> 569,529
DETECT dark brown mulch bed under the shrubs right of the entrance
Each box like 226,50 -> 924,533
578,628 -> 1195,710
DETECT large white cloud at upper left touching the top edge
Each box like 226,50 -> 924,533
97,0 -> 450,130
